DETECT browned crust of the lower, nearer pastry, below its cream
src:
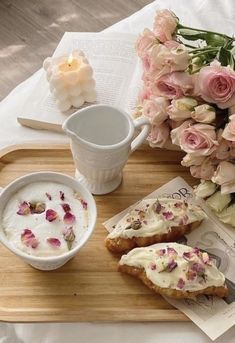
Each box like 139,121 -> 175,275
118,264 -> 228,299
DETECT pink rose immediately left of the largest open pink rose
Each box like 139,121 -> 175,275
150,71 -> 194,99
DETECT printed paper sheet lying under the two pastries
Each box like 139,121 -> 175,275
103,177 -> 235,340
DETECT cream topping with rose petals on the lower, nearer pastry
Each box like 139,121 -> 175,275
119,243 -> 225,291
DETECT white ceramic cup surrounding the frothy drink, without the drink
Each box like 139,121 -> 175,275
0,172 -> 97,270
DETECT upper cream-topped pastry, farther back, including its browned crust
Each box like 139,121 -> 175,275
105,198 -> 205,253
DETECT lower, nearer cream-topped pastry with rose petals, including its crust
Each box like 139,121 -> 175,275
118,243 -> 228,299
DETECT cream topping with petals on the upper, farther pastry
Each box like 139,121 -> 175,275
108,198 -> 205,239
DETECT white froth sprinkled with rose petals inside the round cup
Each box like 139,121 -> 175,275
2,182 -> 89,256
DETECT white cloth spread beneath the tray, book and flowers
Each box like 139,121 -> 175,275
0,0 -> 235,343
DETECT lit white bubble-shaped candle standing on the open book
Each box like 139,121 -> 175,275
43,50 -> 96,112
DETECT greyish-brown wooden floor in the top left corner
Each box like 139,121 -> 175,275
0,0 -> 151,100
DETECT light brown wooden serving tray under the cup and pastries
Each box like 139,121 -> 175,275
0,146 -> 195,322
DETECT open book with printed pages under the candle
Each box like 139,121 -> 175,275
18,32 -> 141,131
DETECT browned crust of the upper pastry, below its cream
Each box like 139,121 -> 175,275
105,221 -> 201,254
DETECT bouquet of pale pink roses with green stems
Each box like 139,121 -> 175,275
134,10 -> 235,226
